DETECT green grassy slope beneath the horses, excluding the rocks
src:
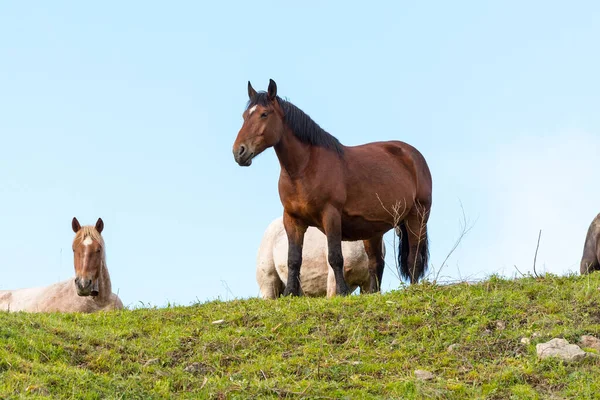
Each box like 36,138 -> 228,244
0,274 -> 600,399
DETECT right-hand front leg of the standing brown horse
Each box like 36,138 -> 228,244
323,207 -> 350,296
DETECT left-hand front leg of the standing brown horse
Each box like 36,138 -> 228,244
283,212 -> 307,296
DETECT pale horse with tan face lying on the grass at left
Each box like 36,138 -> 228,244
0,218 -> 123,313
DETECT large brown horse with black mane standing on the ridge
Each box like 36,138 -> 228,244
233,80 -> 431,295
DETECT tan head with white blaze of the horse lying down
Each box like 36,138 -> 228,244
72,218 -> 104,296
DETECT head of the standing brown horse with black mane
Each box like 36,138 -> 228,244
233,79 -> 284,167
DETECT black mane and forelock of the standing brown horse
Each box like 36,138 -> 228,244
247,92 -> 344,156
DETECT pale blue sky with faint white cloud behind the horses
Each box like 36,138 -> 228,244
0,1 -> 600,306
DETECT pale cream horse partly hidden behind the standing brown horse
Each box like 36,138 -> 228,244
256,217 -> 385,299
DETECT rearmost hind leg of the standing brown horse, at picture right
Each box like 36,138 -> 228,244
404,203 -> 429,284
